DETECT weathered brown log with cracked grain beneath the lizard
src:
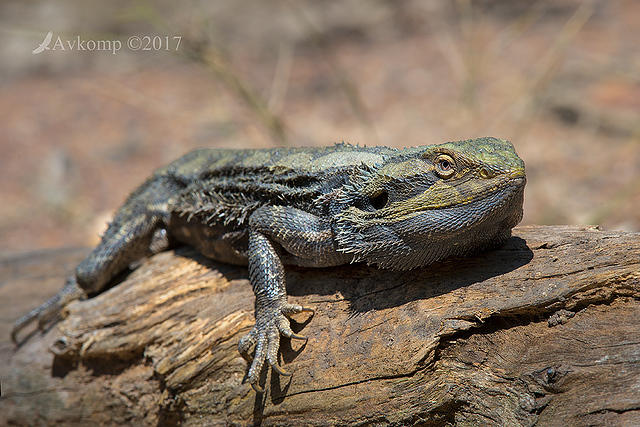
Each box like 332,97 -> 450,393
0,227 -> 640,425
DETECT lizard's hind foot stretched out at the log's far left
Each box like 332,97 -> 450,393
11,278 -> 86,344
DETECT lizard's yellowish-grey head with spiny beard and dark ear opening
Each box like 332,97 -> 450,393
333,138 -> 526,269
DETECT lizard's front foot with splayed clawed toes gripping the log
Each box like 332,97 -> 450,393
238,303 -> 314,393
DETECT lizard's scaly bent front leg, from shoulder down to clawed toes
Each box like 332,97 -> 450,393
238,206 -> 346,392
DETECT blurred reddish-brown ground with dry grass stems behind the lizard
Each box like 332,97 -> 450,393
0,0 -> 640,253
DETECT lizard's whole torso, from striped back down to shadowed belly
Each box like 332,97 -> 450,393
161,144 -> 399,264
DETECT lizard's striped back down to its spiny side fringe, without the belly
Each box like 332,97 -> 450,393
161,144 -> 398,228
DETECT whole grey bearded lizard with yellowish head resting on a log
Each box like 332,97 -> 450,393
12,137 -> 526,392
